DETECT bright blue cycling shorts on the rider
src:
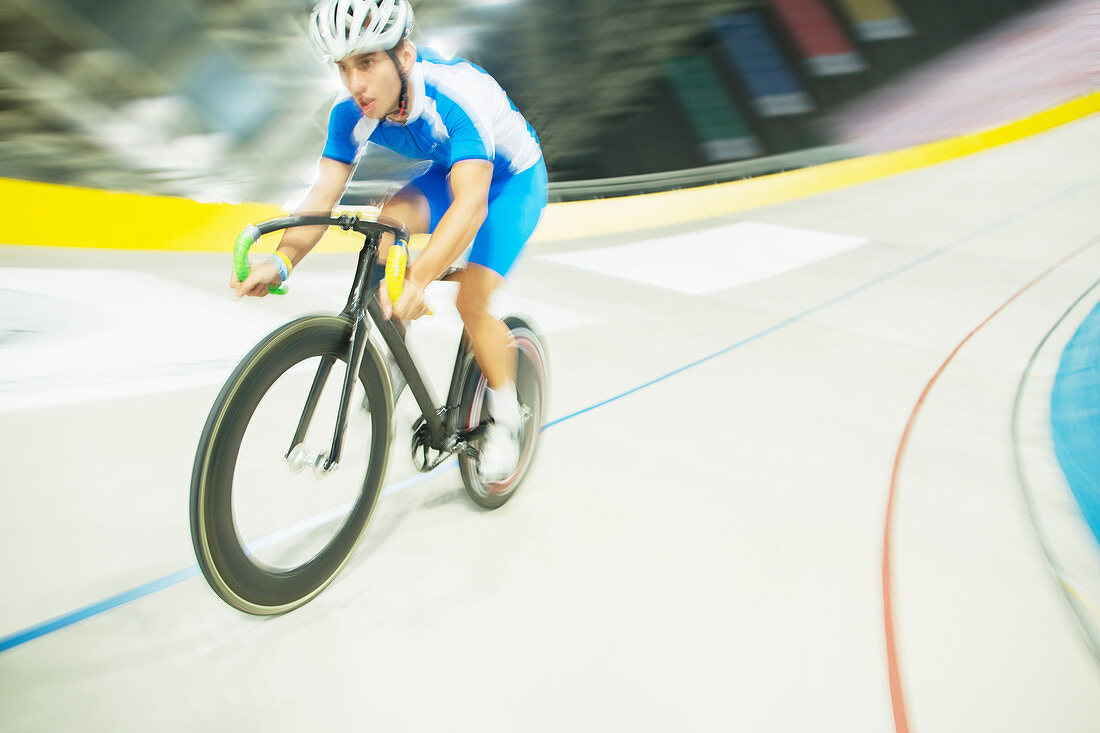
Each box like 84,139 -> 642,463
411,158 -> 547,277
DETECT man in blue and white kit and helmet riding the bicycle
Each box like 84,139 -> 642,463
232,0 -> 547,481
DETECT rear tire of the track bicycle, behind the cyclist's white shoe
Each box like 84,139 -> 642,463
459,316 -> 549,510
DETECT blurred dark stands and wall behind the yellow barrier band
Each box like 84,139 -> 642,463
0,0 -> 1100,206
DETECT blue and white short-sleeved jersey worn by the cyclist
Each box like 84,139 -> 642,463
321,48 -> 542,184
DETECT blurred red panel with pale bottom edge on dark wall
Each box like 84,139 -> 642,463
771,0 -> 867,76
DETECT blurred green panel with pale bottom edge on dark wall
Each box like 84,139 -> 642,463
662,56 -> 761,163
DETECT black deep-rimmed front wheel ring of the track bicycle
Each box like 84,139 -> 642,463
190,315 -> 393,615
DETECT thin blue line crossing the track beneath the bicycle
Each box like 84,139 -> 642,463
0,176 -> 1100,653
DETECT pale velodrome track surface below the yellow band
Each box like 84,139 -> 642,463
0,107 -> 1100,732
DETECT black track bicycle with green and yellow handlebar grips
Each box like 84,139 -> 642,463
190,214 -> 548,615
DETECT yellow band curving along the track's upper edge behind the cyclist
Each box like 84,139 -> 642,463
0,91 -> 1100,252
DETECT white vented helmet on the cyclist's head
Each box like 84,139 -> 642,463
309,0 -> 413,62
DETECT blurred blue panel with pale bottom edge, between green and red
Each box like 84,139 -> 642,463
713,11 -> 814,117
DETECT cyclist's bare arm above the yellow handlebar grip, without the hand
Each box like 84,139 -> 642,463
407,160 -> 493,286
